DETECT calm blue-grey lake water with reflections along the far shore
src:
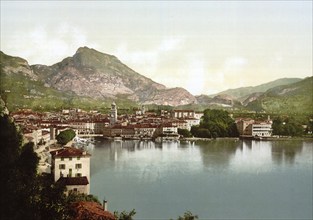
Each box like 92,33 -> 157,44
90,140 -> 313,219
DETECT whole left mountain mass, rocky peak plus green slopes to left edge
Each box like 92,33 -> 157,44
0,47 -> 196,109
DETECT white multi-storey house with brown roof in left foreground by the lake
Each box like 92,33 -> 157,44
51,147 -> 91,194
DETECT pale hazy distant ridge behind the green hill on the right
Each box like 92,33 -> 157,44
210,78 -> 302,102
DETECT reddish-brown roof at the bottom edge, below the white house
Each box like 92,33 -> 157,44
70,201 -> 115,220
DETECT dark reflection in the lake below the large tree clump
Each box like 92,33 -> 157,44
196,140 -> 242,169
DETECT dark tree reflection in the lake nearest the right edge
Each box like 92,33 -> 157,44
272,141 -> 303,164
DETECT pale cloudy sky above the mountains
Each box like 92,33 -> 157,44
0,0 -> 313,95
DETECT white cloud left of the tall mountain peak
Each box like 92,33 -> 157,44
6,23 -> 92,65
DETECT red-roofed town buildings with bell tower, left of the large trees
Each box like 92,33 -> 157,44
11,102 -> 203,146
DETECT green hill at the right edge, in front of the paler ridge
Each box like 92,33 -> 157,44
246,77 -> 313,114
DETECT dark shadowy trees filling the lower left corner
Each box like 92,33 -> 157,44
0,115 -> 67,220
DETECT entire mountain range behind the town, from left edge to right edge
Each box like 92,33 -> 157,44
0,47 -> 312,112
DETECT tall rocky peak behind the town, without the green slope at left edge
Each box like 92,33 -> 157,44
32,47 -> 196,106
